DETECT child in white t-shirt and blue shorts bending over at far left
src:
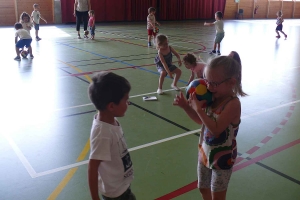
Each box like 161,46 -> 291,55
15,23 -> 33,61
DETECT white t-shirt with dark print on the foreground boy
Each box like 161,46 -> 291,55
90,115 -> 133,198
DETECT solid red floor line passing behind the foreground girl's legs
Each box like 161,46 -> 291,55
155,139 -> 300,200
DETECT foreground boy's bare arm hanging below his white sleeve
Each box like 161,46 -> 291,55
88,159 -> 101,200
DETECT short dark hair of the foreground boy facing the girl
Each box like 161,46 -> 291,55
88,72 -> 131,111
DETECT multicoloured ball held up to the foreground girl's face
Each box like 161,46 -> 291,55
186,78 -> 212,108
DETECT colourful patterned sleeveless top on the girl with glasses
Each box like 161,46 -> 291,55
198,97 -> 239,170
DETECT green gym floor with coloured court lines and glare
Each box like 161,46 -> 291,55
0,19 -> 300,200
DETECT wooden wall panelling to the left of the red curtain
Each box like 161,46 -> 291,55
0,0 -> 54,26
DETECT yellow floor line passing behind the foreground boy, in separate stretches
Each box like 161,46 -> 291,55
47,60 -> 92,200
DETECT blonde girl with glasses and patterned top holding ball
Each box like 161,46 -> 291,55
173,56 -> 247,200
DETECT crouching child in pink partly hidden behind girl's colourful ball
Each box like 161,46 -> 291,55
183,53 -> 205,85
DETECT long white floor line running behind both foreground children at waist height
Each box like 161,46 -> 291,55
32,100 -> 300,177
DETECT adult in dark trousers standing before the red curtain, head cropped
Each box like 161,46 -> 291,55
73,0 -> 91,39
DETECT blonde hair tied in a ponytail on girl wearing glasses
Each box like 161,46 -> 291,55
205,56 -> 247,97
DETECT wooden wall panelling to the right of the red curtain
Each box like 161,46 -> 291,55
224,0 -> 300,19
